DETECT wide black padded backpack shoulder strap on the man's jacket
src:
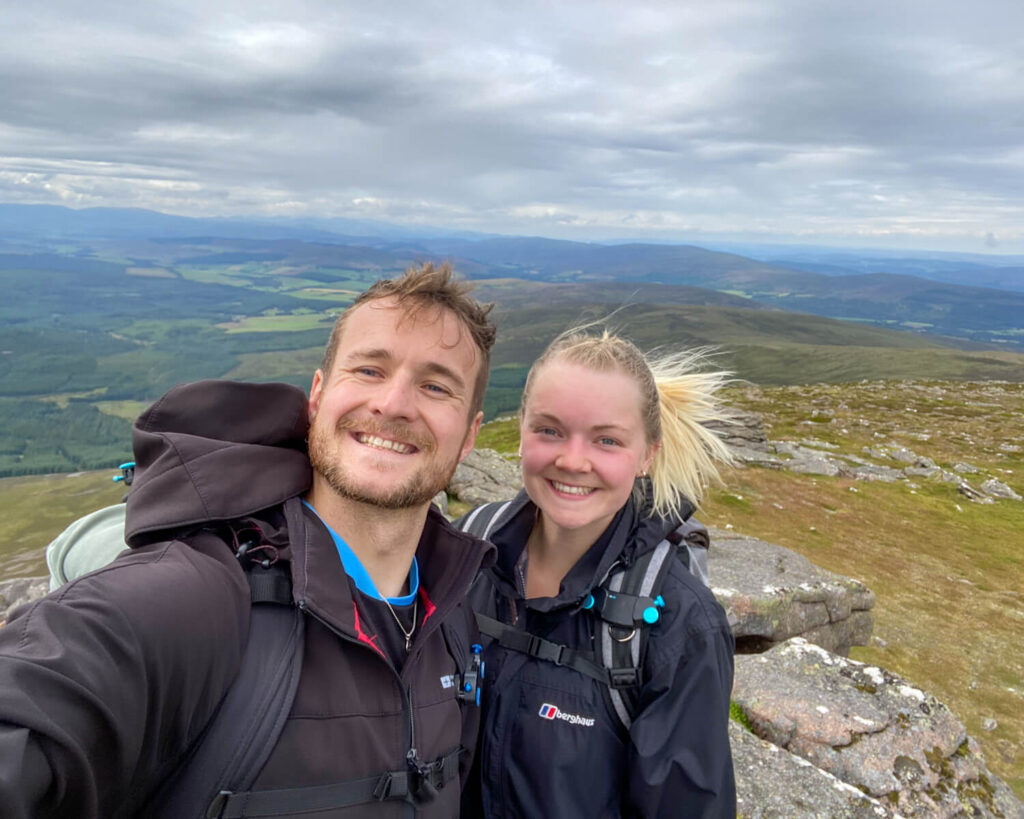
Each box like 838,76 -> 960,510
144,561 -> 304,819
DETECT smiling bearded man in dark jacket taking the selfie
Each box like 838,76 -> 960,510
0,264 -> 495,819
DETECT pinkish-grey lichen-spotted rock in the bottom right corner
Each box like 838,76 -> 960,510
733,639 -> 1024,819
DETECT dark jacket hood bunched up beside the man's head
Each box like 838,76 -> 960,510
125,381 -> 312,547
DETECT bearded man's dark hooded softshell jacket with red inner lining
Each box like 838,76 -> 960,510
0,382 -> 490,819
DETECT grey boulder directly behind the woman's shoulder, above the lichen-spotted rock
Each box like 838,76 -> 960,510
708,529 -> 874,654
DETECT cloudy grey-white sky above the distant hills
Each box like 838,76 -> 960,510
0,0 -> 1024,253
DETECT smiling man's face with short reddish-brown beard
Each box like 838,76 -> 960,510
309,299 -> 482,509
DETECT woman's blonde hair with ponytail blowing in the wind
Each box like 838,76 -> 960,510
519,325 -> 733,517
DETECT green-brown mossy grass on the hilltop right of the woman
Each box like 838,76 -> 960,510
701,383 -> 1024,798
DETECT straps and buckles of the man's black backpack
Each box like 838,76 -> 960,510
59,499 -> 475,819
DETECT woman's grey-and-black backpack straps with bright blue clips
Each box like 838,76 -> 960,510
458,501 -> 709,730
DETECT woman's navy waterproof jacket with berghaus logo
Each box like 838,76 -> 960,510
467,492 -> 736,819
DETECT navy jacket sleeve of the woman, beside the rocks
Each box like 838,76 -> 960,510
628,584 -> 736,819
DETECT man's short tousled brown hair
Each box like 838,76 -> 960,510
321,262 -> 497,415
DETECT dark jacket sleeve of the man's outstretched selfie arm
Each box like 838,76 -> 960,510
0,545 -> 249,819
